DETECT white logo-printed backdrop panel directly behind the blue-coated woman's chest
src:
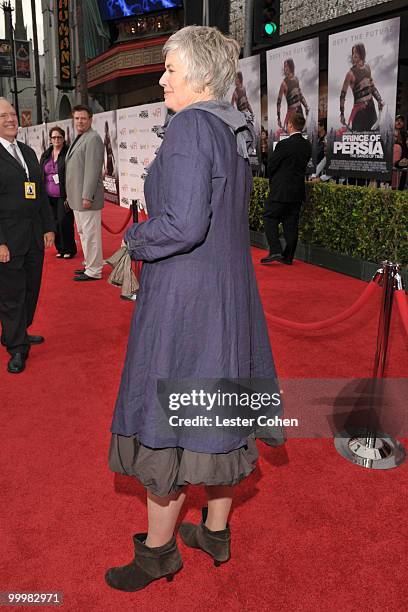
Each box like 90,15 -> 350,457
117,102 -> 167,211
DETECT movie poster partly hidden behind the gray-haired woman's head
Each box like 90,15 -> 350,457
227,55 -> 267,171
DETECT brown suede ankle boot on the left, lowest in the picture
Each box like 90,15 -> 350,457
105,533 -> 183,592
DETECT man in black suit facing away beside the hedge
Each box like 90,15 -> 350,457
261,114 -> 312,265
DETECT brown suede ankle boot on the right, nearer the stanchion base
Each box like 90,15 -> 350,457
179,508 -> 231,567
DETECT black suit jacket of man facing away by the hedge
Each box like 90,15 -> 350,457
268,134 -> 312,202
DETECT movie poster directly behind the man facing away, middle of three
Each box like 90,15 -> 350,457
266,38 -> 319,173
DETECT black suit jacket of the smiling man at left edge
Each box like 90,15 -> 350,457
0,142 -> 55,256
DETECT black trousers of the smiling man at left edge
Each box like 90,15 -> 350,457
0,241 -> 44,355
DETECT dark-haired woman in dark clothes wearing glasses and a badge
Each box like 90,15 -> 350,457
40,126 -> 77,259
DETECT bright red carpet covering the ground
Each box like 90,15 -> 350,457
0,206 -> 408,612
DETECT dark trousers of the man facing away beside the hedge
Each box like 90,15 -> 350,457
264,198 -> 302,261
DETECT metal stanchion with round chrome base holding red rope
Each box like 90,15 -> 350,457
334,261 -> 406,470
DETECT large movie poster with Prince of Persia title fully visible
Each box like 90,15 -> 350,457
326,17 -> 400,180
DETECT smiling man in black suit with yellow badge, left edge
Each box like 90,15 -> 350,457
0,98 -> 54,374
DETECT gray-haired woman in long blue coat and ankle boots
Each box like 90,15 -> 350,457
106,26 -> 275,591
